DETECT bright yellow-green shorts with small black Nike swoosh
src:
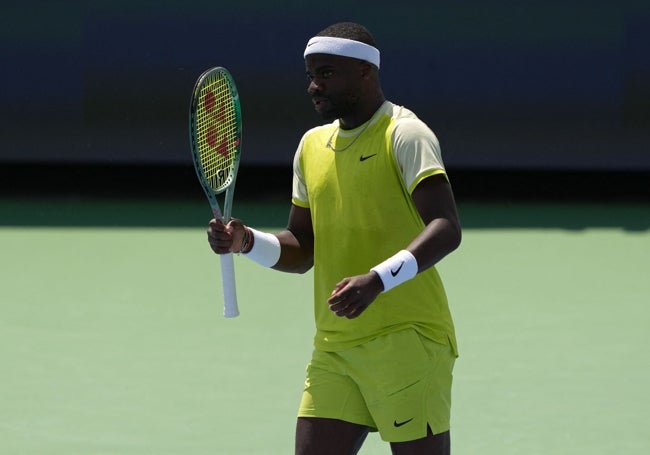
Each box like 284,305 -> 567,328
298,329 -> 456,442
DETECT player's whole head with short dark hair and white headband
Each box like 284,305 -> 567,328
304,22 -> 383,128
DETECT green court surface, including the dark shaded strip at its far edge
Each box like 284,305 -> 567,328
0,198 -> 650,455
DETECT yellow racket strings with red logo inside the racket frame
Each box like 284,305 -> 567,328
196,77 -> 239,188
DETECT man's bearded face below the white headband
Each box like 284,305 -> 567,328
305,54 -> 362,121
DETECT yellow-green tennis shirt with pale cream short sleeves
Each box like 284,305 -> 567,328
292,101 -> 457,353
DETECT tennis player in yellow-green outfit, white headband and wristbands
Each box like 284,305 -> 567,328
208,23 -> 461,455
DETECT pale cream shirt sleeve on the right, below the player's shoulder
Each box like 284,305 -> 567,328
393,118 -> 447,194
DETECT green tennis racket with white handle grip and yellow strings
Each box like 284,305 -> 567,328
190,67 -> 241,318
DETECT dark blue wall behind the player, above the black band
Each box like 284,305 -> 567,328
0,0 -> 650,170
